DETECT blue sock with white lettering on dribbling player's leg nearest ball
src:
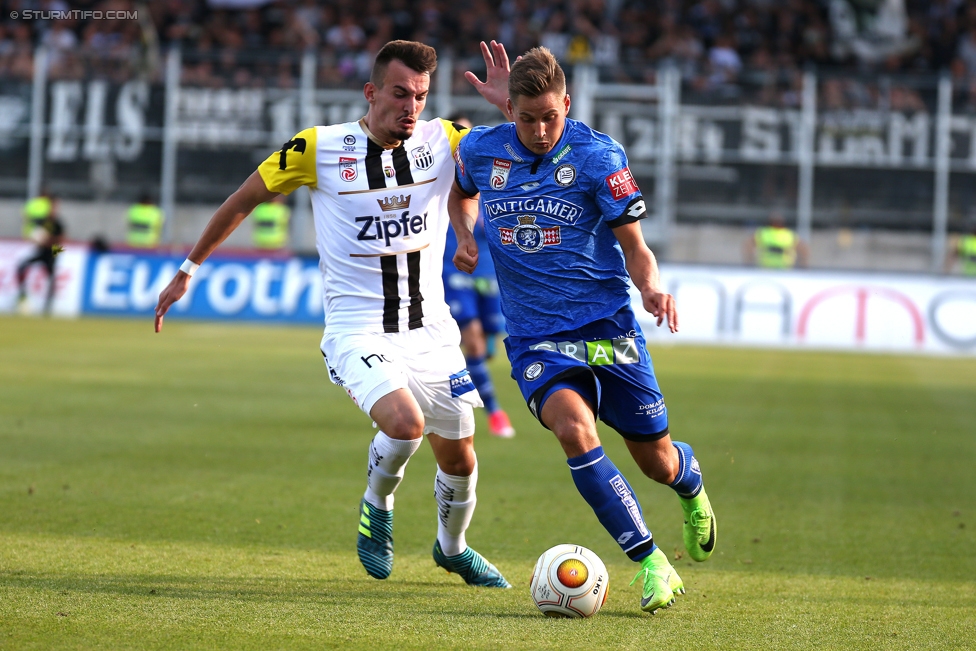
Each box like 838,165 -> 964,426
566,446 -> 657,561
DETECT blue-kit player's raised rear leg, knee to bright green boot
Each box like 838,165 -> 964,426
627,435 -> 718,561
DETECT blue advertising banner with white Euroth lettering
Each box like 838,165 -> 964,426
82,252 -> 324,324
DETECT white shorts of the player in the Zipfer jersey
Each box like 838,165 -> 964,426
321,319 -> 482,439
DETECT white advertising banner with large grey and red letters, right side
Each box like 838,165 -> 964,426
631,264 -> 976,355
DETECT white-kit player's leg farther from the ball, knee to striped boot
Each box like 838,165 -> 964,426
356,389 -> 424,579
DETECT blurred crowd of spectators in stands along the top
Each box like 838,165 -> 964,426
0,0 -> 976,110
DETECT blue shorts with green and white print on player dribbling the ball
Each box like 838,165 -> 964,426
505,306 -> 668,441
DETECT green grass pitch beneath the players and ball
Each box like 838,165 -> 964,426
0,317 -> 976,650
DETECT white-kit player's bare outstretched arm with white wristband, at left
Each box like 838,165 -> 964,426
156,172 -> 278,332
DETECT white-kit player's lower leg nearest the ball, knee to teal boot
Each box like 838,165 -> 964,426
427,434 -> 511,588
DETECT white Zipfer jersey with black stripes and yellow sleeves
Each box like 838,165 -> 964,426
258,119 -> 467,332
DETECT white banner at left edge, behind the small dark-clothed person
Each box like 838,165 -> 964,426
0,239 -> 88,317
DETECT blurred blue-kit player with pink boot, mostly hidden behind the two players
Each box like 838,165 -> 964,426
444,115 -> 515,438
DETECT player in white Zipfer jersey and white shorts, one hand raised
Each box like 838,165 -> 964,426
156,41 -> 510,588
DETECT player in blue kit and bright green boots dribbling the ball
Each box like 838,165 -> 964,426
448,47 -> 716,613
